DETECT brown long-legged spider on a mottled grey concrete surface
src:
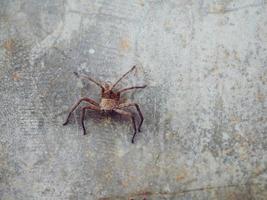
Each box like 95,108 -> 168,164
63,66 -> 146,143
